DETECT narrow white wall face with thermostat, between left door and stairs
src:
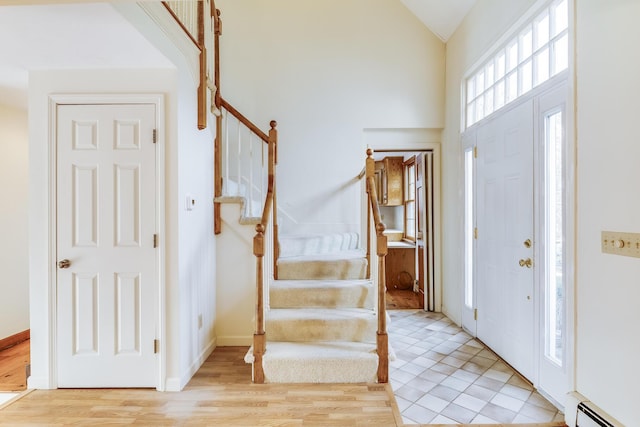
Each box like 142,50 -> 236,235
175,69 -> 218,389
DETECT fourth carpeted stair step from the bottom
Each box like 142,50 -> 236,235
278,250 -> 367,280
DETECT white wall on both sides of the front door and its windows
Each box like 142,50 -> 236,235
443,0 -> 640,426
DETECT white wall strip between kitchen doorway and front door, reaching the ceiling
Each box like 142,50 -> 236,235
442,0 -> 535,324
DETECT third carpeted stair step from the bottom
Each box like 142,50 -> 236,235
269,279 -> 375,309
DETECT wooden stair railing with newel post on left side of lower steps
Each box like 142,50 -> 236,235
253,121 -> 278,384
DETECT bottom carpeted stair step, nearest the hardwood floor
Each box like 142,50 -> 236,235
262,342 -> 378,383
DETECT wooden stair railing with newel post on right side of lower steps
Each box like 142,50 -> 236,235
359,148 -> 389,383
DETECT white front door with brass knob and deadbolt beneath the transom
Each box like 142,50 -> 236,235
476,101 -> 536,381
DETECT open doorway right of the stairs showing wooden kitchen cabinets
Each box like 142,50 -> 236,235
373,150 -> 439,311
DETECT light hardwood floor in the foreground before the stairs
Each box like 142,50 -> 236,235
0,347 -> 563,427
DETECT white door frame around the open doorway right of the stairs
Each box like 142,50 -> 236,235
362,142 -> 443,313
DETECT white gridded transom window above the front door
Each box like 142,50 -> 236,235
466,0 -> 569,127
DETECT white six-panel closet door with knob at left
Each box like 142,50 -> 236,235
56,104 -> 158,387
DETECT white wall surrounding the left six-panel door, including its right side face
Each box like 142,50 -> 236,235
29,61 -> 215,390
